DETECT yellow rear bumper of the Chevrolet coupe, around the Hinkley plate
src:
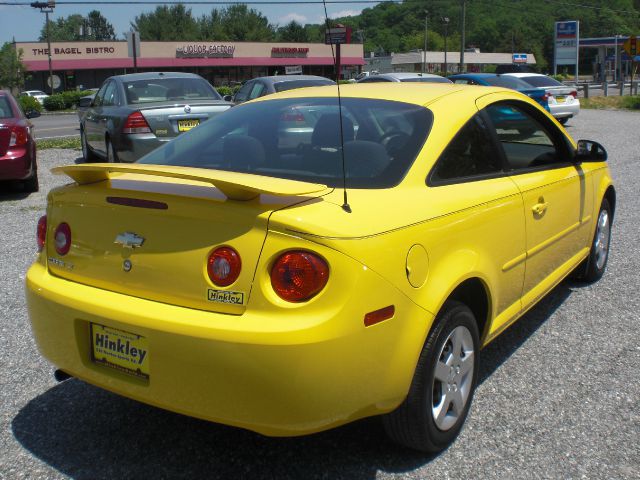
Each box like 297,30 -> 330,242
26,263 -> 433,436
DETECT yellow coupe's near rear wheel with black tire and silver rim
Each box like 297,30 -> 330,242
383,301 -> 480,453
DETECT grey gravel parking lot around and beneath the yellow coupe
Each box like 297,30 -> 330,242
0,110 -> 640,479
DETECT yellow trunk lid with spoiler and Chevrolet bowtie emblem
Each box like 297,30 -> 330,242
46,164 -> 326,314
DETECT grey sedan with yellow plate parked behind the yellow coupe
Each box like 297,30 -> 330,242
80,72 -> 231,162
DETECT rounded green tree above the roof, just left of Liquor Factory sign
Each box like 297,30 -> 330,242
131,4 -> 200,41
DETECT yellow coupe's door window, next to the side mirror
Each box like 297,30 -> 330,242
486,103 -> 565,170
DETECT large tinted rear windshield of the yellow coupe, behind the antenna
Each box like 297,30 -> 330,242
138,98 -> 433,188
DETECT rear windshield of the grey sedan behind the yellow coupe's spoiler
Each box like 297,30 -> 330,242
123,78 -> 222,104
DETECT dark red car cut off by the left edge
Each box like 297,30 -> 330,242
0,90 -> 40,192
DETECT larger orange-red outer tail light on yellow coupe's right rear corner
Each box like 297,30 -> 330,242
271,251 -> 329,302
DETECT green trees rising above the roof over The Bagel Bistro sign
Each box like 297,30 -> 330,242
40,10 -> 116,42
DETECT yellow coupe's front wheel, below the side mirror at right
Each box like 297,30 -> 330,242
573,198 -> 613,283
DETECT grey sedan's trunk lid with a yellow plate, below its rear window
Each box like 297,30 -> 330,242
140,100 -> 231,137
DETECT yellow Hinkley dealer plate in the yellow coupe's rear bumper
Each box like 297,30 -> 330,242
91,323 -> 149,379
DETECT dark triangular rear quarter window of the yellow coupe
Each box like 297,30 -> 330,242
430,114 -> 502,183
